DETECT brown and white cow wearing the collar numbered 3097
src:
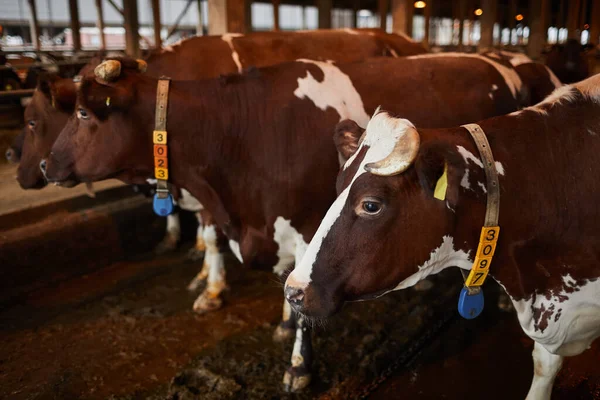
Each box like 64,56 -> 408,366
285,75 -> 600,400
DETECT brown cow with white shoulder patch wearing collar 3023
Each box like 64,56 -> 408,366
43,50 -> 540,391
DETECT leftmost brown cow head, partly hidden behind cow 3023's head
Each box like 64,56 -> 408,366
13,75 -> 76,189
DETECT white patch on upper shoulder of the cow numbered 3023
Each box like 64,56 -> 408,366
294,59 -> 369,128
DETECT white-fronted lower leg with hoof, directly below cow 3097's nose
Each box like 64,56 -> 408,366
283,313 -> 312,392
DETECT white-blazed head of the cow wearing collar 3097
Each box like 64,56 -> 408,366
285,112 -> 466,316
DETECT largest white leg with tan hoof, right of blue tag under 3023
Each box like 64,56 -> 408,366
194,224 -> 227,314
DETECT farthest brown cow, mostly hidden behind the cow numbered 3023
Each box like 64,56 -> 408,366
11,29 -> 425,316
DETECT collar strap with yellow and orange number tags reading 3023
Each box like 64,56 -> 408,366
152,77 -> 170,199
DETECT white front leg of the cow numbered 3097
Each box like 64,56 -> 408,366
525,342 -> 563,400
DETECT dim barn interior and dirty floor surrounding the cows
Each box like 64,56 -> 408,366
0,0 -> 600,400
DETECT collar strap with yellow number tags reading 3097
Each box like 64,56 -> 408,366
463,124 -> 500,290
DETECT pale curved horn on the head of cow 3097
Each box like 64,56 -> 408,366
365,127 -> 421,176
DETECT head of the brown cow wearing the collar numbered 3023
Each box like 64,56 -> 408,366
41,58 -> 156,184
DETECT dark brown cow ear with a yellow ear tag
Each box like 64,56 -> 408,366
415,144 -> 465,209
